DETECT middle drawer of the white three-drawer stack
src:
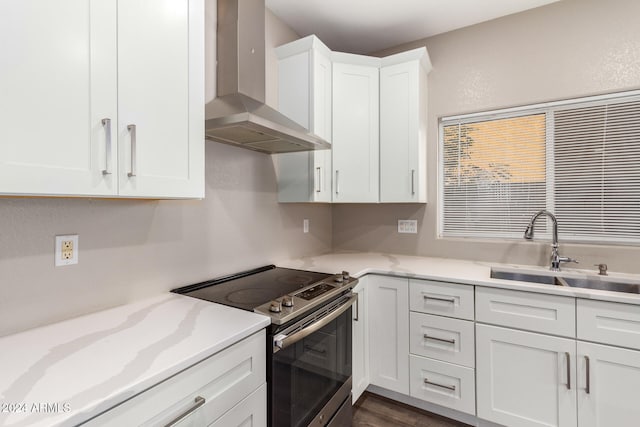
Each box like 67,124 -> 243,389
409,312 -> 475,368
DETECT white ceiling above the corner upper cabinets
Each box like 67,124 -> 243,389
265,0 -> 559,53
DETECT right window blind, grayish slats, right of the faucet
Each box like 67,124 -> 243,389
554,100 -> 640,242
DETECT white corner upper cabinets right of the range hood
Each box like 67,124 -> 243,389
274,36 -> 431,203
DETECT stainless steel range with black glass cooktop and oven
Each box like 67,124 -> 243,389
174,265 -> 358,427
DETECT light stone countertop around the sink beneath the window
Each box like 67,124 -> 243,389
278,252 -> 640,305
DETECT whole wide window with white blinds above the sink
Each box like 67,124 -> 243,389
439,92 -> 640,244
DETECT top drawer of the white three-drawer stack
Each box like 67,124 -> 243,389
409,279 -> 473,320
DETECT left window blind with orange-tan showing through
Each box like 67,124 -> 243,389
442,114 -> 546,237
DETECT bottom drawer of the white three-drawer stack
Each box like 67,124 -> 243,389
409,355 -> 476,415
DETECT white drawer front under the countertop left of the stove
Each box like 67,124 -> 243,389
85,330 -> 266,426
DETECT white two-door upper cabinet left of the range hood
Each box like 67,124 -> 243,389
0,0 -> 204,197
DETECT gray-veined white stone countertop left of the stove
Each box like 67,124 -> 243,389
0,294 -> 270,427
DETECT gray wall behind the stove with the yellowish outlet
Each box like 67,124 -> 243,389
0,6 -> 331,335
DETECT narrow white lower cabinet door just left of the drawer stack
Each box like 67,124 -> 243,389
367,276 -> 409,394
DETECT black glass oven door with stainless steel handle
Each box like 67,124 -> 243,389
270,292 -> 356,427
